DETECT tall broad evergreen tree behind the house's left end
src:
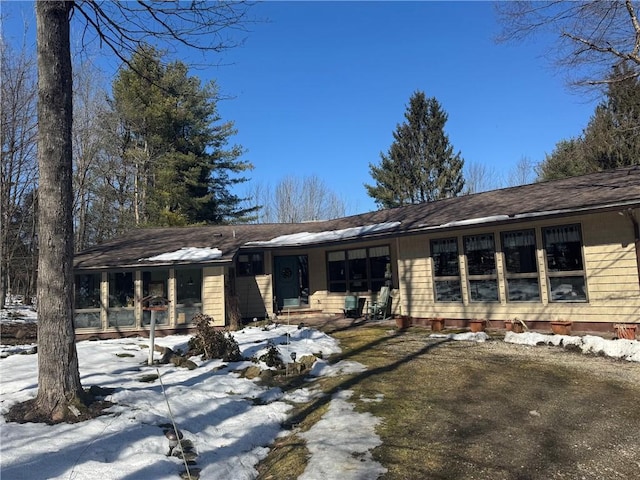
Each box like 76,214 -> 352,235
113,46 -> 252,225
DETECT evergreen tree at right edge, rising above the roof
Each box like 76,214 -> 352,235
538,65 -> 640,180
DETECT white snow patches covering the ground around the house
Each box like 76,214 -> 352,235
0,307 -> 640,480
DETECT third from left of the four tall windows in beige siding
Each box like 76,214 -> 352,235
502,230 -> 540,302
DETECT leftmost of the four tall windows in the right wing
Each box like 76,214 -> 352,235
431,238 -> 462,302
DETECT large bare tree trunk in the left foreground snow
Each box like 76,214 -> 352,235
36,1 -> 82,422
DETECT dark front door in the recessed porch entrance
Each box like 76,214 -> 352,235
273,255 -> 308,310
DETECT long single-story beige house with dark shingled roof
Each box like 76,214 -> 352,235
74,166 -> 640,337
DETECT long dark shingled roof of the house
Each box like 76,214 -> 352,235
74,166 -> 640,269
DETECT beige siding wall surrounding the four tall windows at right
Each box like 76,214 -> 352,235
396,212 -> 640,322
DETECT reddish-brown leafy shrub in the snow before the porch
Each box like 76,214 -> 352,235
189,313 -> 242,362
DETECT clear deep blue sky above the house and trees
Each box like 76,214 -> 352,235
3,1 -> 595,214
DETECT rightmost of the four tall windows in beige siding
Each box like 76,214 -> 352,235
542,225 -> 587,302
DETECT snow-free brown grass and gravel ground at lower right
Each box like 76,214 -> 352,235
265,323 -> 640,480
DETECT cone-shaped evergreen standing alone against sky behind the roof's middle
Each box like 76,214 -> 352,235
365,91 -> 464,208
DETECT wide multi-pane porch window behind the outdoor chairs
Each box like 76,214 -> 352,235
327,245 -> 391,292
